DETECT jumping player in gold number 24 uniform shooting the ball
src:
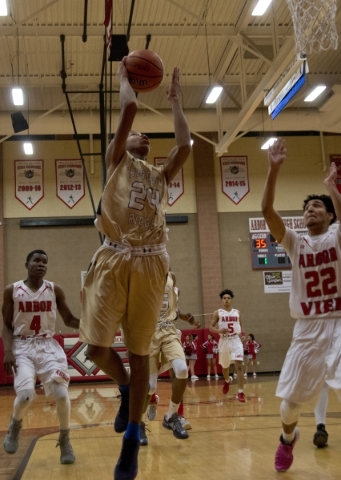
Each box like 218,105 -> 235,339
80,57 -> 191,480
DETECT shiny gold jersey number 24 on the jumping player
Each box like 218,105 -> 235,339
96,152 -> 168,246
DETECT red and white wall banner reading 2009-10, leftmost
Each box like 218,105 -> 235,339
14,160 -> 44,210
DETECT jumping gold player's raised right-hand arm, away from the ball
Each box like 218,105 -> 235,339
163,67 -> 191,183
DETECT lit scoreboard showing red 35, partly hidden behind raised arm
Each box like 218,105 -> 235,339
249,216 -> 307,270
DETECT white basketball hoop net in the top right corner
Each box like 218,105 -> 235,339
286,0 -> 338,54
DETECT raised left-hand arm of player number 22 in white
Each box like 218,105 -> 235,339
262,138 -> 286,242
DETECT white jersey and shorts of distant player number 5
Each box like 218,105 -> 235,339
218,308 -> 244,368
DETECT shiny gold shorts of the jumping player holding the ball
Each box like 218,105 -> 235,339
79,246 -> 169,355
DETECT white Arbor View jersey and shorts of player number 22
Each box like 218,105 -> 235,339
276,228 -> 341,404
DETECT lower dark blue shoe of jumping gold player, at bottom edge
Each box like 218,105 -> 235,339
114,438 -> 140,480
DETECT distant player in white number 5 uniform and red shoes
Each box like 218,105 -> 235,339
209,289 -> 245,403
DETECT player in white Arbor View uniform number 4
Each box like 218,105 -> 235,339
2,250 -> 79,464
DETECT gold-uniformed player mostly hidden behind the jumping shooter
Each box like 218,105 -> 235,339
140,272 -> 201,445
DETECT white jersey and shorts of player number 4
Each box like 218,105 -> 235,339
13,280 -> 70,396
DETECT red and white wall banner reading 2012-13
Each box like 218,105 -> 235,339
56,159 -> 85,208
